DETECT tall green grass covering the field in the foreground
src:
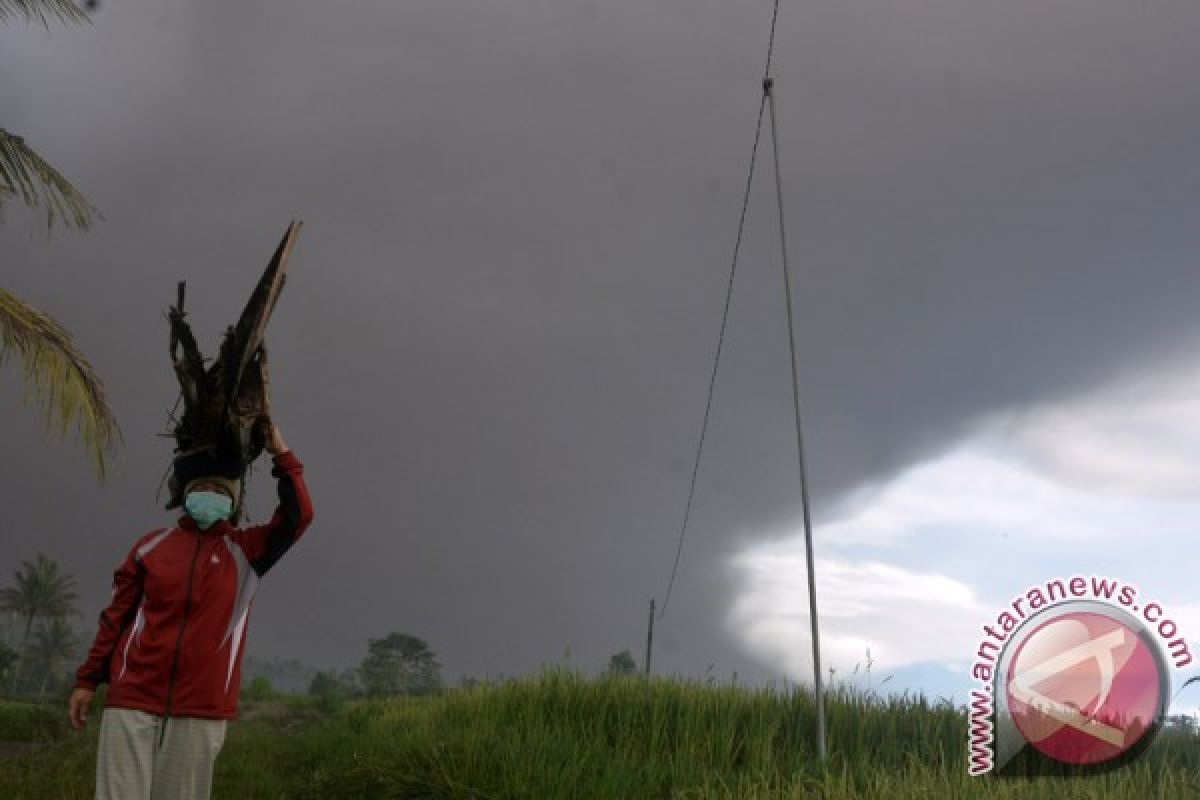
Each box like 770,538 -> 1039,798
0,669 -> 1200,800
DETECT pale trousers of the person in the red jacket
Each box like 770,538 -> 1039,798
96,709 -> 226,800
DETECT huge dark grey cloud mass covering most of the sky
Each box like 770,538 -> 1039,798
0,0 -> 1200,678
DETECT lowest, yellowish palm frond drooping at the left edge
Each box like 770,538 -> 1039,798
0,289 -> 121,480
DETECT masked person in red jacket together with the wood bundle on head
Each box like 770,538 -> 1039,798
67,223 -> 312,800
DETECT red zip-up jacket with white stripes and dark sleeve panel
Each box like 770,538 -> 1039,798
76,451 -> 312,720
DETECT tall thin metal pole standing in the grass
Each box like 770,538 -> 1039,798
762,76 -> 826,760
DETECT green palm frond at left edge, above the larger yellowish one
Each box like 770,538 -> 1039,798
0,128 -> 101,228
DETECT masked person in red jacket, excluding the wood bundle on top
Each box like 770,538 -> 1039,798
70,425 -> 313,800
